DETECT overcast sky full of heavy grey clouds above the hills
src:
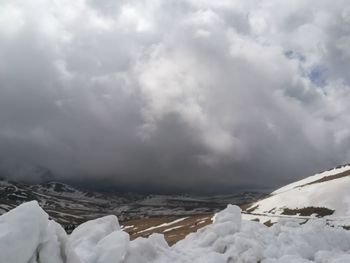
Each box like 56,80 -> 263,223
0,0 -> 350,193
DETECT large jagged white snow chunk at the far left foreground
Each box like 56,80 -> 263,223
0,201 -> 66,263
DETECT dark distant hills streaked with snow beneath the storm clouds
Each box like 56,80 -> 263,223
0,180 -> 263,231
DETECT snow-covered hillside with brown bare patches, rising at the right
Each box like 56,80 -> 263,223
246,165 -> 350,225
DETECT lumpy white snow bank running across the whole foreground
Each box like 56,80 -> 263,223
0,202 -> 350,263
